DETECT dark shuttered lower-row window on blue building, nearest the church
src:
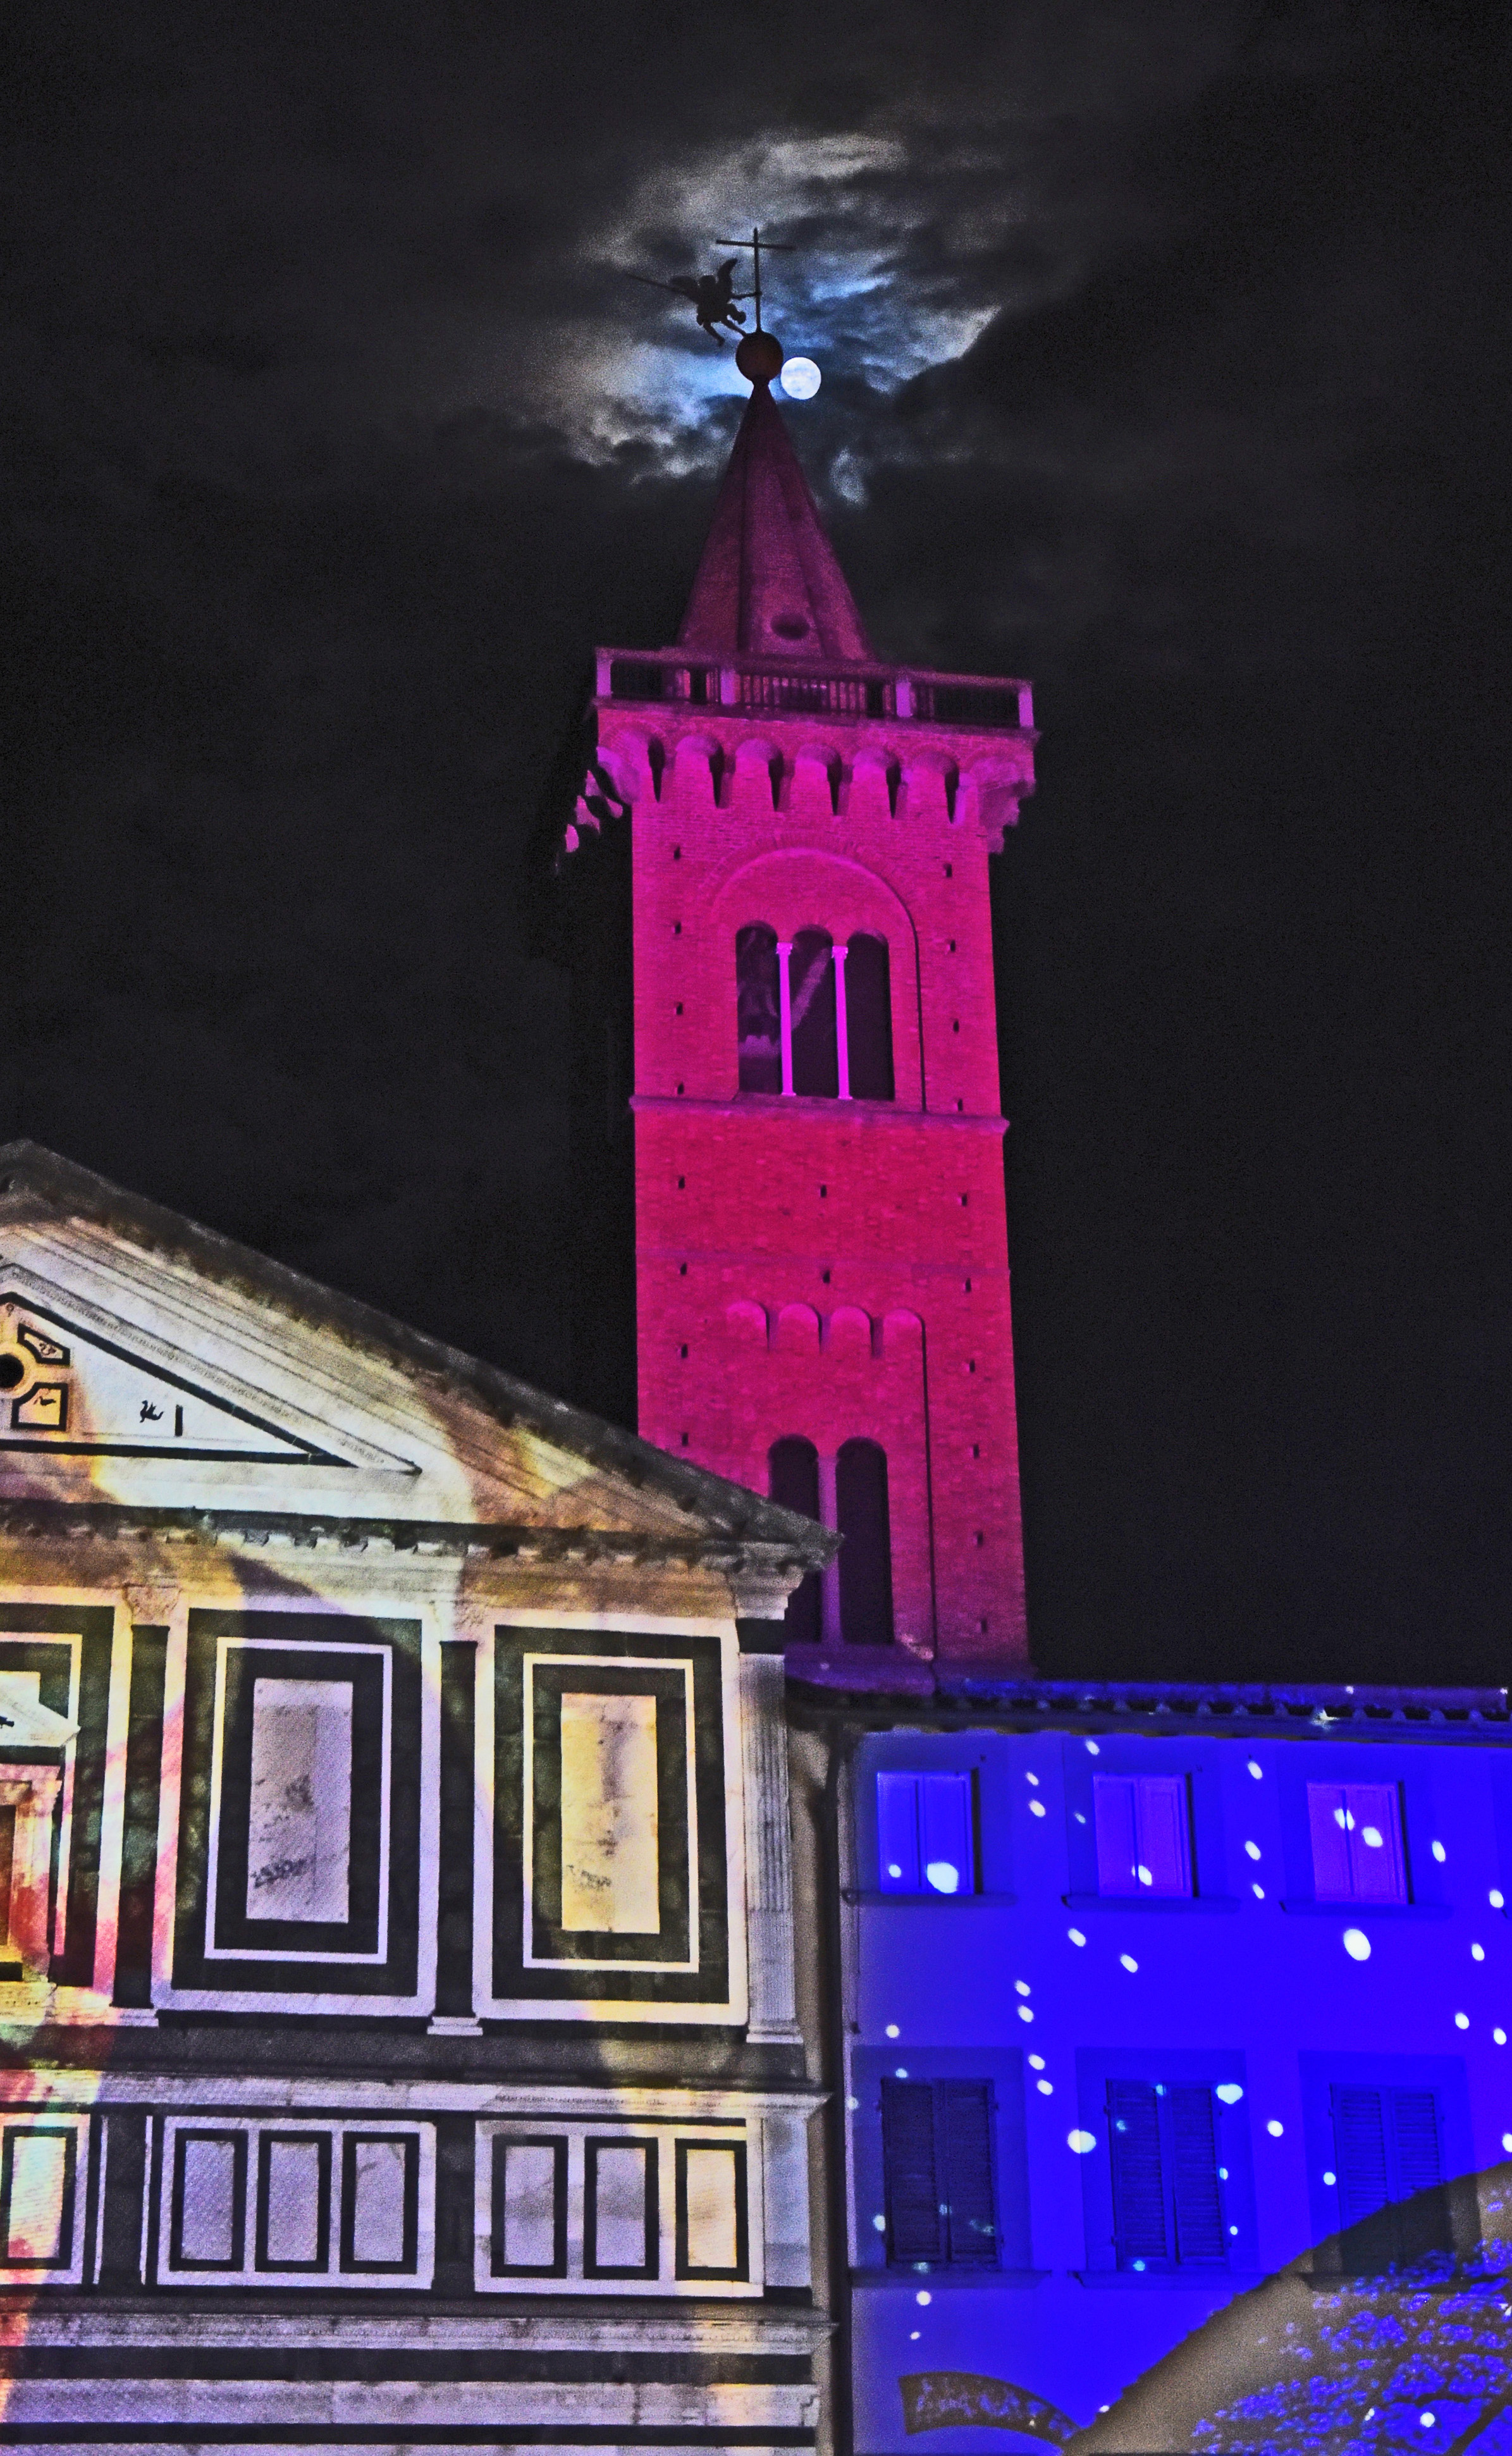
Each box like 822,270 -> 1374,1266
881,2080 -> 997,2269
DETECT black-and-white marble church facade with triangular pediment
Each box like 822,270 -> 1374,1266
0,1147 -> 832,2448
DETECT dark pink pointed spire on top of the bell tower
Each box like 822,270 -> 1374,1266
677,371 -> 871,663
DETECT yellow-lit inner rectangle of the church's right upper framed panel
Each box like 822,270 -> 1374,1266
562,1690 -> 660,1935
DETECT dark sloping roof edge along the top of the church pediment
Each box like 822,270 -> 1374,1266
0,1140 -> 839,1569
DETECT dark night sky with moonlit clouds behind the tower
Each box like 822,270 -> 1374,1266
0,0 -> 1512,1680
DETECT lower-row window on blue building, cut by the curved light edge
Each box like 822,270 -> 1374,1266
1331,2083 -> 1453,2272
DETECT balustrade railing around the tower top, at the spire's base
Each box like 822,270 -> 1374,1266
596,648 -> 1033,732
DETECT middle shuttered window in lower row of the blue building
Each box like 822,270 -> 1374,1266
1107,2080 -> 1230,2272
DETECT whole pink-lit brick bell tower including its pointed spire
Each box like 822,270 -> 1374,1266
579,334 -> 1033,1672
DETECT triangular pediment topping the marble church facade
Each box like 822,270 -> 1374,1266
0,1144 -> 832,1560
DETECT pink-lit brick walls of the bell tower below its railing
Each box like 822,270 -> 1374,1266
599,700 -> 1031,1668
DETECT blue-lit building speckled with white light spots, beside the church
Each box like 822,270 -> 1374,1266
793,1663 -> 1512,2456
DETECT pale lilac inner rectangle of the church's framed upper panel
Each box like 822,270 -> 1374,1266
245,1680 -> 353,1925
